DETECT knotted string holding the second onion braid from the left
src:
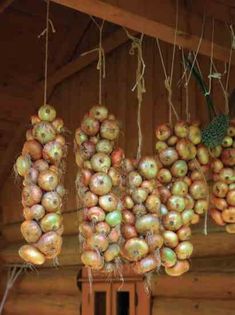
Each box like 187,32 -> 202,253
81,16 -> 106,104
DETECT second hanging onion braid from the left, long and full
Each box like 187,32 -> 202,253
75,105 -> 124,271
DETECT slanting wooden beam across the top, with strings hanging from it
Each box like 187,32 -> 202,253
52,0 -> 235,65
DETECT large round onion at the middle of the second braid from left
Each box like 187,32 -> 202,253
89,172 -> 112,196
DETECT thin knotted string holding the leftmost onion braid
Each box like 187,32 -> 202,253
38,0 -> 55,105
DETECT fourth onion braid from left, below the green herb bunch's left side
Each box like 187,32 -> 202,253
155,121 -> 209,276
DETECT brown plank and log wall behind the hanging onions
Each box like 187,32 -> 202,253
0,38 -> 235,315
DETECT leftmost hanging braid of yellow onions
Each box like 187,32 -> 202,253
15,105 -> 67,265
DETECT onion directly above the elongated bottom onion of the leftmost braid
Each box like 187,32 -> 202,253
20,220 -> 42,243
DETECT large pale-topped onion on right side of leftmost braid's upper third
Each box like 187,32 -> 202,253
42,141 -> 64,164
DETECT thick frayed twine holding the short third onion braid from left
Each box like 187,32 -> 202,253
124,28 -> 146,159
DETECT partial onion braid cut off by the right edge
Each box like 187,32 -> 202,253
210,121 -> 235,233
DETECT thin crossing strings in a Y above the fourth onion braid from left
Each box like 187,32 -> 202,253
156,0 -> 179,125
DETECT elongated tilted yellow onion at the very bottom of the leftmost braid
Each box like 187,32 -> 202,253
19,245 -> 45,265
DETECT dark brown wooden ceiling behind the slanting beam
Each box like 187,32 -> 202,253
0,0 -> 235,187
